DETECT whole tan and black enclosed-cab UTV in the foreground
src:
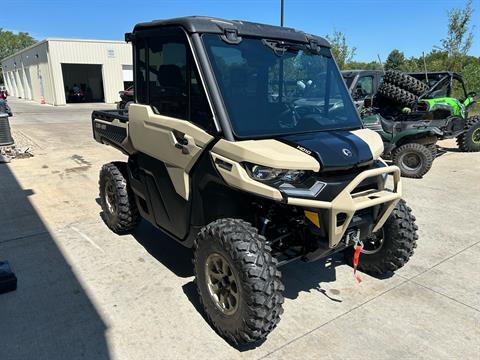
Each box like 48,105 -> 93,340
92,17 -> 417,344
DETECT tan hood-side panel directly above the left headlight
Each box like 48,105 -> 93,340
212,139 -> 320,171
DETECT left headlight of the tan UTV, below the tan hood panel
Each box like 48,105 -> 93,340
245,164 -> 326,197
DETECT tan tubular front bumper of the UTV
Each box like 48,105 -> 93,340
287,166 -> 402,248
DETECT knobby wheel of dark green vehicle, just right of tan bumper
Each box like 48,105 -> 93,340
392,143 -> 434,179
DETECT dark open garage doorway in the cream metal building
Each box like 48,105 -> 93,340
62,64 -> 105,103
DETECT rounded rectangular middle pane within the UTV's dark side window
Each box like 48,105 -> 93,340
148,38 -> 188,120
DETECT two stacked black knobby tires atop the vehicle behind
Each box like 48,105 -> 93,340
377,70 -> 428,108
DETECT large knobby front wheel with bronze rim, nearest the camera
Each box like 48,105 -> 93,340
194,219 -> 284,345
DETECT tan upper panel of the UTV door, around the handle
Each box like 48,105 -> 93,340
128,104 -> 213,200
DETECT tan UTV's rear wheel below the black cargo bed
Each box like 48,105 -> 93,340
98,162 -> 140,234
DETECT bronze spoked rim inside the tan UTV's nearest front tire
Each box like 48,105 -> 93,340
205,253 -> 240,315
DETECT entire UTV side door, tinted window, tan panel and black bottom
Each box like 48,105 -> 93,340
129,28 -> 213,239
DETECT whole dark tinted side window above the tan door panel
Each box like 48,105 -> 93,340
135,29 -> 216,132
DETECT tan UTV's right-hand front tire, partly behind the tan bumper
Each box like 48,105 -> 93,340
345,200 -> 418,276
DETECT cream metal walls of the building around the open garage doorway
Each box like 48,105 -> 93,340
2,39 -> 133,105
